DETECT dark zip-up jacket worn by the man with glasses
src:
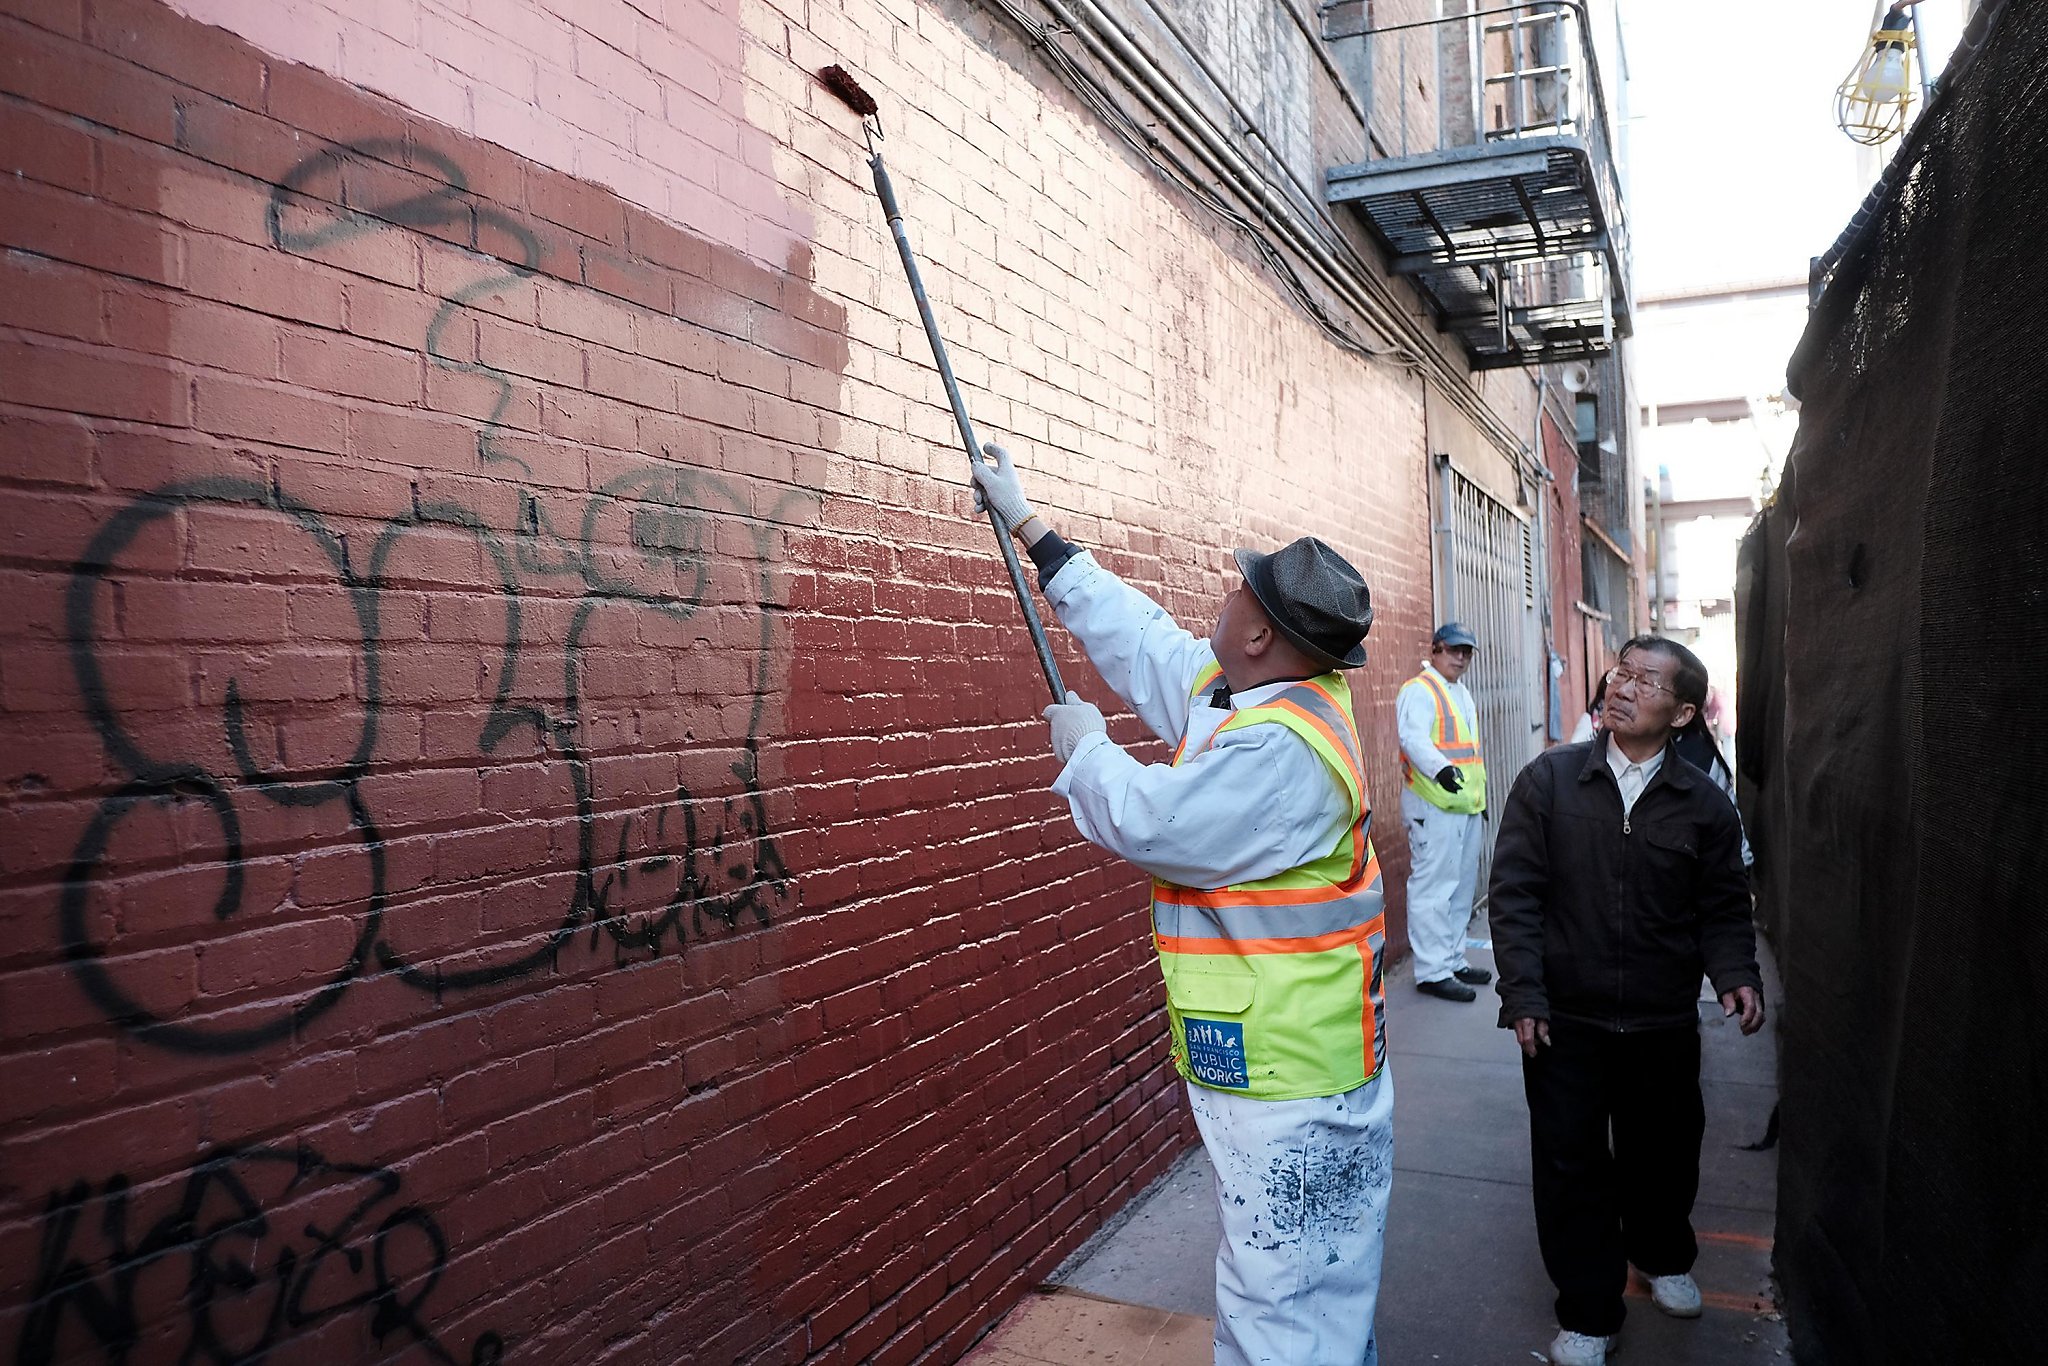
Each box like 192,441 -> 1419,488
1487,733 -> 1763,1030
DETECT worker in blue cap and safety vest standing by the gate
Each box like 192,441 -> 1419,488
1395,621 -> 1493,1001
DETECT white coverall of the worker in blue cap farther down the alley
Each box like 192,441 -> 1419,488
1395,664 -> 1483,981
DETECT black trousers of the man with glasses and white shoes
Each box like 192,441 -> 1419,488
1522,1020 -> 1706,1335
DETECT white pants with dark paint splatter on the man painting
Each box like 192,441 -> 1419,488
1188,1067 -> 1395,1366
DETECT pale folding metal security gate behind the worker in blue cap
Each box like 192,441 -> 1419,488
1438,463 -> 1546,905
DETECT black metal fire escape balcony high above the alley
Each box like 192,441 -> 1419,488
1325,0 -> 1630,369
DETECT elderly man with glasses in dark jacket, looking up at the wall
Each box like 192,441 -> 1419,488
1489,635 -> 1763,1366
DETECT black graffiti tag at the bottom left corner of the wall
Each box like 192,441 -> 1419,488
16,1145 -> 504,1366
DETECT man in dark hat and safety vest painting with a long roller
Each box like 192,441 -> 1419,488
975,446 -> 1395,1366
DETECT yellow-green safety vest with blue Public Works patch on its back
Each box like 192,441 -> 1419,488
1153,664 -> 1386,1100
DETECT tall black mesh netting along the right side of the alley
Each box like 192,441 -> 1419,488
1737,0 -> 2048,1366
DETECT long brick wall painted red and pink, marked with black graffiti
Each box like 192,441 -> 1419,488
0,0 -> 1430,1364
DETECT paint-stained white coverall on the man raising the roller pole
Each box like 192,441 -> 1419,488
1044,551 -> 1395,1366
